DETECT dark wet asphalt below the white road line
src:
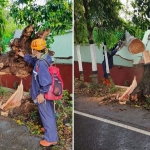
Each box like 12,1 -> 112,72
74,114 -> 150,150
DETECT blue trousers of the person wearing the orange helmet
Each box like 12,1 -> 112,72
38,100 -> 58,142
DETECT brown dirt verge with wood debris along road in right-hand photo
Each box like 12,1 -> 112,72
75,80 -> 150,110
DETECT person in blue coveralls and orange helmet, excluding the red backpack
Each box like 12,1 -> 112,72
18,39 -> 58,146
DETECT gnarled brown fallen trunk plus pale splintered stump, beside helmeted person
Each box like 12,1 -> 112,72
0,25 -> 54,111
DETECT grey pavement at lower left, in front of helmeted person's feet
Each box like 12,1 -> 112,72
0,116 -> 51,150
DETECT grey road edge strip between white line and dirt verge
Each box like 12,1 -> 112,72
74,94 -> 150,131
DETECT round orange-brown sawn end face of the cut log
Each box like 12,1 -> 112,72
128,38 -> 145,54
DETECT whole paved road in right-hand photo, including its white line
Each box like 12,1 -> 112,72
74,95 -> 150,150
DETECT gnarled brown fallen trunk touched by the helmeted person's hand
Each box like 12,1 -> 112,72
0,25 -> 54,78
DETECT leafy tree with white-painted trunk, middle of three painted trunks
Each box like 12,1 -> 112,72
75,0 -> 122,82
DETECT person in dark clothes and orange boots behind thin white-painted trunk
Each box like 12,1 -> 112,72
102,41 -> 124,86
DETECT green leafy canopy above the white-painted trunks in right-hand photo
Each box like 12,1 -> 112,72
74,0 -> 124,45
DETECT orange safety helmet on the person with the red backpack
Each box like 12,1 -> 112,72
31,39 -> 46,51
